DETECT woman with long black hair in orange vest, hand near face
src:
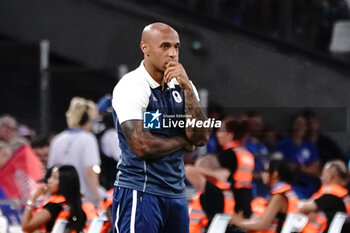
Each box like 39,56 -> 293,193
22,165 -> 87,232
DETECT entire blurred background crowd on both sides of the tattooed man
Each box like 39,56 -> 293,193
0,95 -> 350,233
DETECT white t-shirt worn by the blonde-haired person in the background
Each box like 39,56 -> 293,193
47,130 -> 101,200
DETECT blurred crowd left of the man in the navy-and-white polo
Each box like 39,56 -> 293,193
0,95 -> 120,232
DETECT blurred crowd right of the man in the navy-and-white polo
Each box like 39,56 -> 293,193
186,106 -> 350,233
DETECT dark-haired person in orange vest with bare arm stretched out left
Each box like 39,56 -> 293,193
229,159 -> 299,233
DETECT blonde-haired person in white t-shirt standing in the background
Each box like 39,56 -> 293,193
48,97 -> 104,205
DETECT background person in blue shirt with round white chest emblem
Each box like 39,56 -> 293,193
276,115 -> 321,199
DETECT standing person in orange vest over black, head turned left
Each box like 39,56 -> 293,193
216,118 -> 254,218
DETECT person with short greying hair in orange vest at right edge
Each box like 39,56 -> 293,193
299,160 -> 350,233
